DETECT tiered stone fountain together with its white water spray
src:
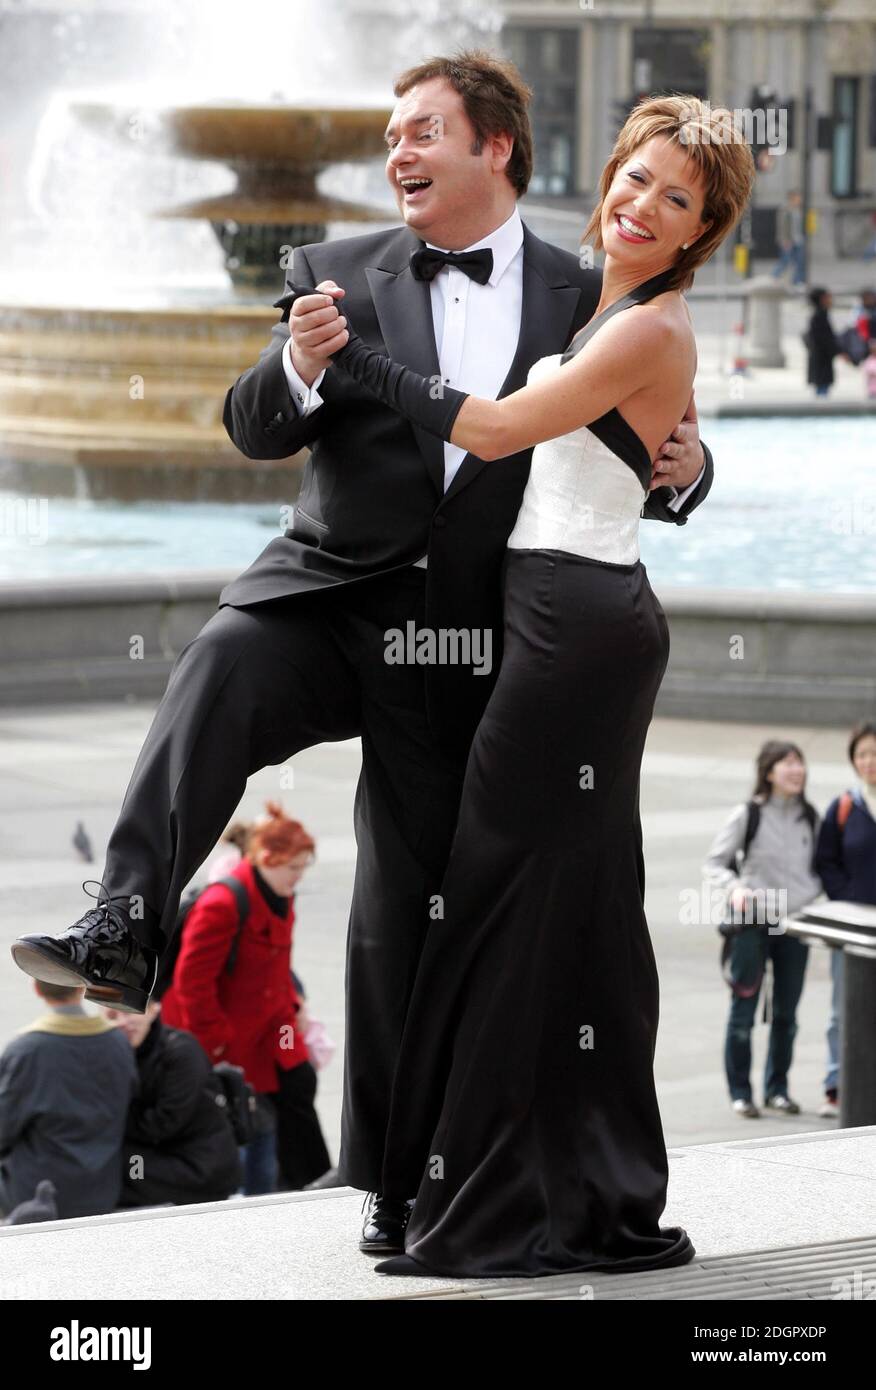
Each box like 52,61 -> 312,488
0,0 -> 508,525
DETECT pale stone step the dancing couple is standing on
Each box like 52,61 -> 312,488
0,1126 -> 876,1301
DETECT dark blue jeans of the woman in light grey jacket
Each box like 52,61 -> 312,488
724,927 -> 809,1101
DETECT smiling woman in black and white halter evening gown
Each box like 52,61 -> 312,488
285,97 -> 752,1277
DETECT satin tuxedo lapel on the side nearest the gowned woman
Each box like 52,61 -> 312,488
445,222 -> 581,498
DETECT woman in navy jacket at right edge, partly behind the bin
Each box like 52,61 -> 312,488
815,723 -> 876,1116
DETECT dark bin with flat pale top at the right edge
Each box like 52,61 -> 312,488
781,901 -> 876,1129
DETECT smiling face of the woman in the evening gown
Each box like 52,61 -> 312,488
601,135 -> 709,274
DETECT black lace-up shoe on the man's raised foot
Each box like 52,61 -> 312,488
11,880 -> 159,1013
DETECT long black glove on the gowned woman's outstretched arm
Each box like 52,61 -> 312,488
274,285 -> 467,439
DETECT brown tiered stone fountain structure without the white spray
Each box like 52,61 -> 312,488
0,101 -> 389,500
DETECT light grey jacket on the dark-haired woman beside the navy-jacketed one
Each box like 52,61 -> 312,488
702,795 -> 822,912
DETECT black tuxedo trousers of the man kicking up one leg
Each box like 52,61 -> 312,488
103,567 -> 464,1191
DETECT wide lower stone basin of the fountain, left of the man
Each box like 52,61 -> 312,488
0,304 -> 280,499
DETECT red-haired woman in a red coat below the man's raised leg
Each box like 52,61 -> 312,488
161,801 -> 331,1191
